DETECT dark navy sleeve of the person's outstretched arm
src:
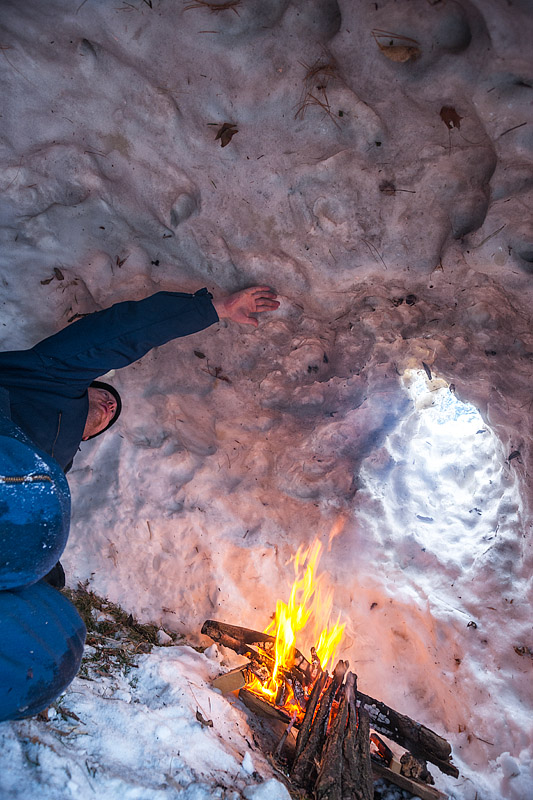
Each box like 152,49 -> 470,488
31,289 -> 218,388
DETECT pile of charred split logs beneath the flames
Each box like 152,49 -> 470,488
202,620 -> 459,800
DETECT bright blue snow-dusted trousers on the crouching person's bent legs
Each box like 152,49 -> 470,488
0,387 -> 85,722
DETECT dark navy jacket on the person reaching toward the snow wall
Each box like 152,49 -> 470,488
0,289 -> 218,469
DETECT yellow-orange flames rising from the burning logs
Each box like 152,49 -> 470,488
247,536 -> 345,713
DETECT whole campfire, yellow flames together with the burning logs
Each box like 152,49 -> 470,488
202,541 -> 459,800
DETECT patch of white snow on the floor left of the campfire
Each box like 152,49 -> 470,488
0,646 -> 296,800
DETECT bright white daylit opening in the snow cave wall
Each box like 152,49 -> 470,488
361,369 -> 519,569
